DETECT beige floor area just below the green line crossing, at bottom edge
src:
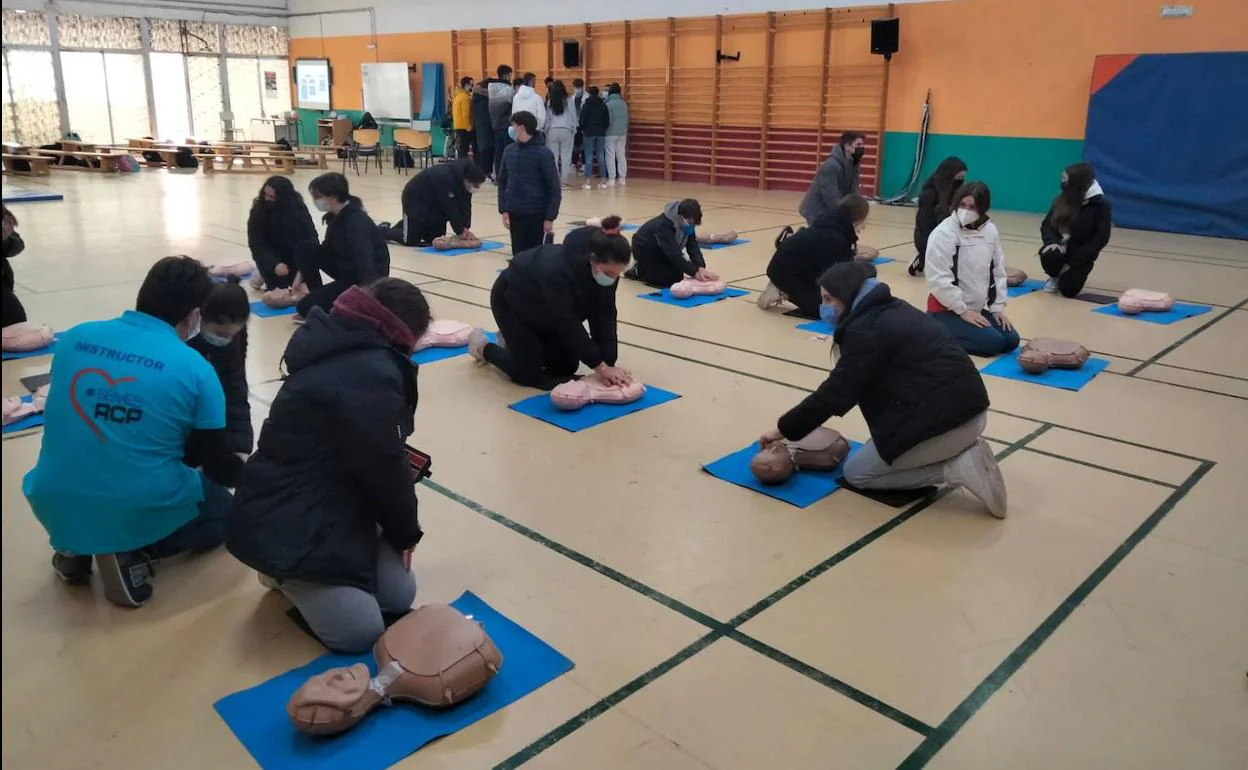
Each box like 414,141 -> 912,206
618,640 -> 920,770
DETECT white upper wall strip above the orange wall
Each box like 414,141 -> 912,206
288,0 -> 943,37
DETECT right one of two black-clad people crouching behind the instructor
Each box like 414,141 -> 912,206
293,172 -> 389,318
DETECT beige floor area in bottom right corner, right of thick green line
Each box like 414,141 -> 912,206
929,538 -> 1248,770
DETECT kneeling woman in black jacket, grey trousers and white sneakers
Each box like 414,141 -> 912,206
760,262 -> 1006,518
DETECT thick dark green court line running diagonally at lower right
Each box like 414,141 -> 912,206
897,461 -> 1216,770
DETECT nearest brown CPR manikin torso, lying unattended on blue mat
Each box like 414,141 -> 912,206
286,604 -> 503,735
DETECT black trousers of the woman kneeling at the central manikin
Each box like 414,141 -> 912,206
485,278 -> 580,391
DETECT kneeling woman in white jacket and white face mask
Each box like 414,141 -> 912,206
924,182 -> 1018,356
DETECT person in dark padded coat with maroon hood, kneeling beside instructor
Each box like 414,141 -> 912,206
226,278 -> 429,653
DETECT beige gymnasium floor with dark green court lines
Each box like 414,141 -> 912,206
2,168 -> 1248,770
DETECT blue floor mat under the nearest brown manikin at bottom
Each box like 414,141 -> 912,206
215,592 -> 573,770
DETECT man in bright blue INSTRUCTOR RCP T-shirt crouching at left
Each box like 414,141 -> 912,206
22,256 -> 243,607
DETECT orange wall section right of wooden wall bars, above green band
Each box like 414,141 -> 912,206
885,0 -> 1248,139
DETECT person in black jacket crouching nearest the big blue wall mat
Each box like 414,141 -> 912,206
1040,163 -> 1113,297
